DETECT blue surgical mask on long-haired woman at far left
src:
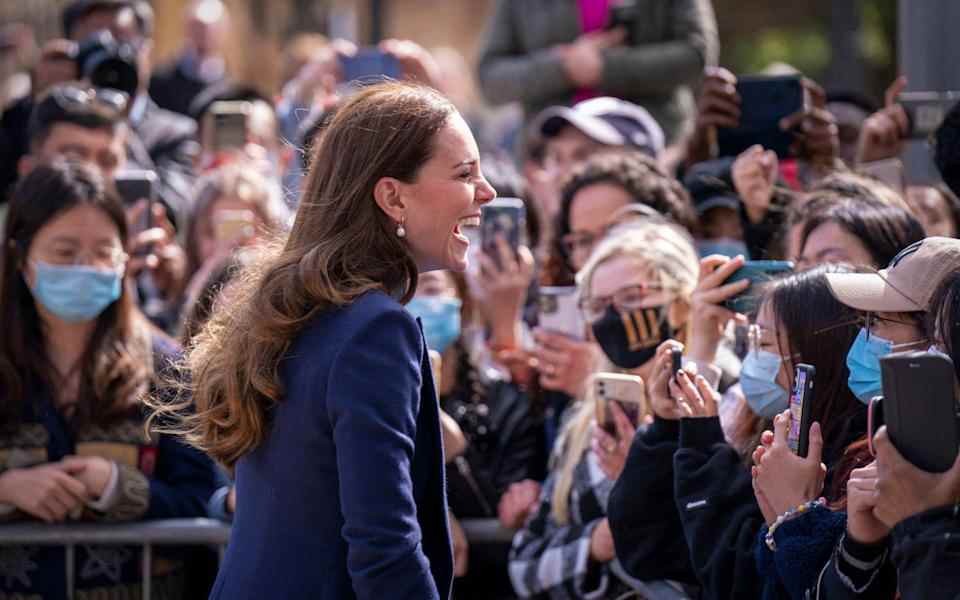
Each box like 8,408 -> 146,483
31,261 -> 123,322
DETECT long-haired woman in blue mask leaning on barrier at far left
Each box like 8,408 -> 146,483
0,162 -> 215,598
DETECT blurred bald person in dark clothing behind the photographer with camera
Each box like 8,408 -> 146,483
149,0 -> 230,116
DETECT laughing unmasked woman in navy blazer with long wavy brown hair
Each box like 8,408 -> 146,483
152,83 -> 495,600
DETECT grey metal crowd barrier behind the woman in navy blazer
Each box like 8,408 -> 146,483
0,519 -> 514,600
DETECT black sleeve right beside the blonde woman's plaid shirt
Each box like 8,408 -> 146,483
607,417 -> 698,584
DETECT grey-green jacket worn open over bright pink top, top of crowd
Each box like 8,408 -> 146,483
478,0 -> 719,142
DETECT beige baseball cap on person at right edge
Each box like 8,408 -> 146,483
827,237 -> 960,312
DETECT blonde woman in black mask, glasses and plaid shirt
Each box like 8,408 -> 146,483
510,218 -> 697,598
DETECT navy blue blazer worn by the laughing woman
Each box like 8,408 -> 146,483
211,292 -> 453,600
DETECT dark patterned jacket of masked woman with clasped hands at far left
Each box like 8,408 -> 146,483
0,340 -> 216,600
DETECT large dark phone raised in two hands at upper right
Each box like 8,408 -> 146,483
717,75 -> 806,158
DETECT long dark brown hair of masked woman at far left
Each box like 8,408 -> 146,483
0,160 -> 154,430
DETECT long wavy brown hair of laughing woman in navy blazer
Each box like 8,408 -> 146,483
150,83 -> 456,468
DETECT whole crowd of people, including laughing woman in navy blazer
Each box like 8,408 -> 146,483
0,0 -> 960,600
